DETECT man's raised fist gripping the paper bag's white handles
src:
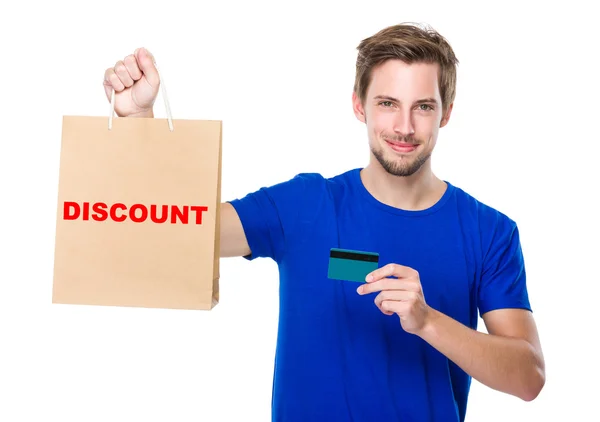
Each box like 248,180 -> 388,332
104,48 -> 160,117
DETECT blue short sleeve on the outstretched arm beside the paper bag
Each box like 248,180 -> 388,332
228,173 -> 324,262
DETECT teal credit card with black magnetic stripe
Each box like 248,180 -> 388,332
327,248 -> 379,283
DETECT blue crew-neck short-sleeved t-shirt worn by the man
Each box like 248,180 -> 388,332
230,169 -> 531,422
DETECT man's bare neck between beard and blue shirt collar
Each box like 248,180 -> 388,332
360,160 -> 447,211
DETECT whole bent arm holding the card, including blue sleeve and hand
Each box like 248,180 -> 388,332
359,219 -> 545,401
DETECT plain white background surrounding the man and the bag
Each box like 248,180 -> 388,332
0,1 -> 600,422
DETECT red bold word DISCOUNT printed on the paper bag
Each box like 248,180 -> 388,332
63,201 -> 208,224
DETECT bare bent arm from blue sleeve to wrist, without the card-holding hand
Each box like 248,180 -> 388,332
416,309 -> 545,401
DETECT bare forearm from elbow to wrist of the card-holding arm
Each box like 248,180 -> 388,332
417,310 -> 544,401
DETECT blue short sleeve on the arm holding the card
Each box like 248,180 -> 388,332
478,214 -> 531,315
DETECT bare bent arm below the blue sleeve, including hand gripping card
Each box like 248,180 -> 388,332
358,264 -> 545,401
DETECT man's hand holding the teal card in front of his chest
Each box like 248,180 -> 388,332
357,264 -> 433,334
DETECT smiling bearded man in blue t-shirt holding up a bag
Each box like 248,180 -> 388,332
105,25 -> 545,422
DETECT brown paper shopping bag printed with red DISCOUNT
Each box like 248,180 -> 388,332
52,112 -> 221,310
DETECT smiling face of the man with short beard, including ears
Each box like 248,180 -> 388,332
352,60 -> 452,176
